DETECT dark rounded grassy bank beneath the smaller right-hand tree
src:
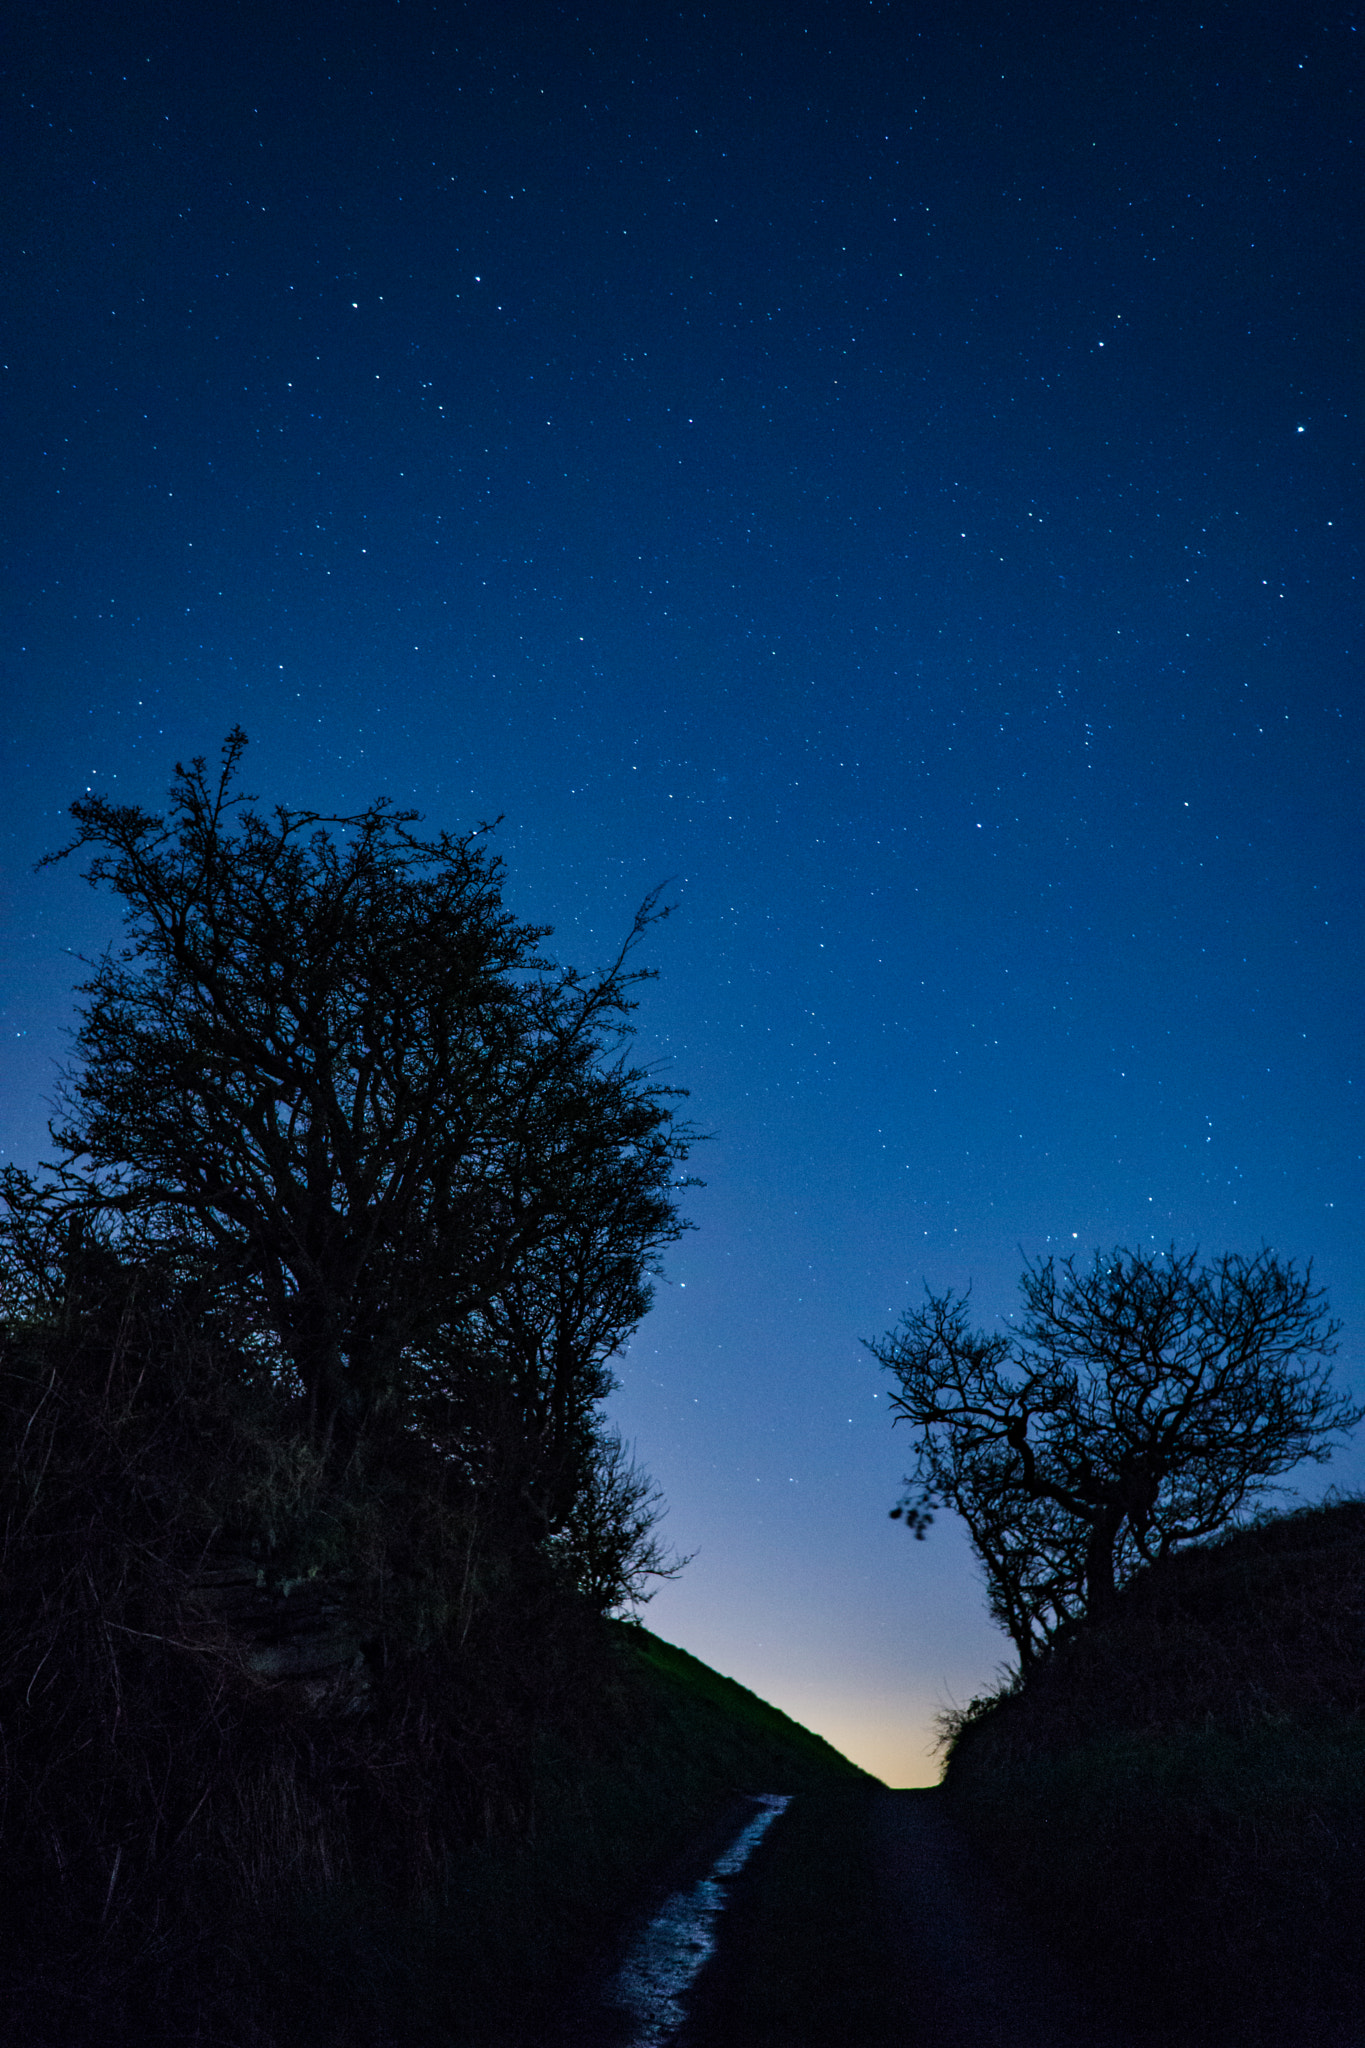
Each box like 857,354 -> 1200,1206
945,1499 -> 1365,2048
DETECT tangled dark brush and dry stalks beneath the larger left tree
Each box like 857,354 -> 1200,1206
0,1260 -> 612,2042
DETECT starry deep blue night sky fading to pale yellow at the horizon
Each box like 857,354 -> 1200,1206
0,0 -> 1365,1784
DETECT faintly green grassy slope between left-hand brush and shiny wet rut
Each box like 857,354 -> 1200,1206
245,1624 -> 864,2048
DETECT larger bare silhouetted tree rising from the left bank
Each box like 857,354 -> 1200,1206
37,729 -> 692,1499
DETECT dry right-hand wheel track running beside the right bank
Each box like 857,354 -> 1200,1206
874,1790 -> 1138,2048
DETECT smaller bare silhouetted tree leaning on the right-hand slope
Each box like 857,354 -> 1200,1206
868,1247 -> 1365,1667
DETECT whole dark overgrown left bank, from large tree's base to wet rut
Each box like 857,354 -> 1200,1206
0,1260 -> 863,2048
